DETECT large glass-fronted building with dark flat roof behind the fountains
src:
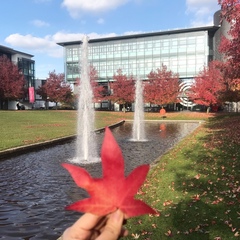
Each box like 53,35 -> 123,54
58,11 -> 226,111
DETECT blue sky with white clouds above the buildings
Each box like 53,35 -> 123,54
0,0 -> 220,79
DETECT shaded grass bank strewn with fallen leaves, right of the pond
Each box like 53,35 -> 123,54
127,113 -> 240,240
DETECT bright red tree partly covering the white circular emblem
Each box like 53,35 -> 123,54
188,61 -> 224,106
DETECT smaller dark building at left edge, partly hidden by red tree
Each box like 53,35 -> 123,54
0,45 -> 35,109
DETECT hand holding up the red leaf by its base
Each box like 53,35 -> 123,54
59,210 -> 128,240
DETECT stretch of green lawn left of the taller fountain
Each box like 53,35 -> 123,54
0,111 -> 76,150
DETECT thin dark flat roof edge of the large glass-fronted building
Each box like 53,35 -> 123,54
57,26 -> 220,47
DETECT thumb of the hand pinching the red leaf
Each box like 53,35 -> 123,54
96,210 -> 124,240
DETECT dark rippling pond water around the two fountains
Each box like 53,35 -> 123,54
0,122 -> 199,240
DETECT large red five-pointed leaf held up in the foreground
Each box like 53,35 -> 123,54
62,127 -> 156,217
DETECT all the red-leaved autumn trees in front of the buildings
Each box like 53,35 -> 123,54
0,0 -> 240,110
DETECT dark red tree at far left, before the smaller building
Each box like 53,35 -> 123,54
0,56 -> 25,106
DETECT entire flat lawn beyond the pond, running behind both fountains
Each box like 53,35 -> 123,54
0,110 -> 212,151
